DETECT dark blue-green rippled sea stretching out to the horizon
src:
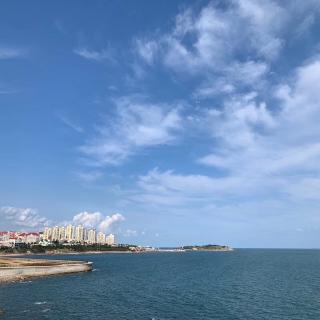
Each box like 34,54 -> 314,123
0,249 -> 320,320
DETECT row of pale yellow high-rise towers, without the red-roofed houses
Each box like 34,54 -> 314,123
43,224 -> 115,245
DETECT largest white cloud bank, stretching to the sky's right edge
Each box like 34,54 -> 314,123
124,57 -> 320,208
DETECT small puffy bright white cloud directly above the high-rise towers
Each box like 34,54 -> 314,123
73,211 -> 124,232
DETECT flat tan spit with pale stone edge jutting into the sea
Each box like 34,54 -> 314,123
0,258 -> 92,283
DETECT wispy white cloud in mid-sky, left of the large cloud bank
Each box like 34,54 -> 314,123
80,99 -> 181,165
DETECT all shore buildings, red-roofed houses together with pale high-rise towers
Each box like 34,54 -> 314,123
0,225 -> 115,247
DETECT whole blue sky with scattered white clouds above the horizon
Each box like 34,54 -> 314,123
0,0 -> 320,248
